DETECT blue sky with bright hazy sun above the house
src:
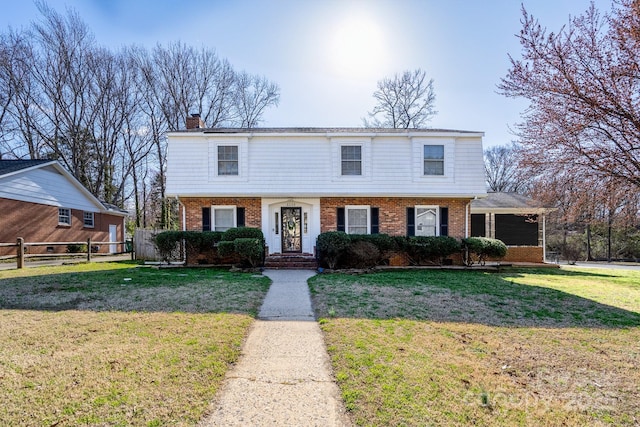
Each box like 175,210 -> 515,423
0,0 -> 611,147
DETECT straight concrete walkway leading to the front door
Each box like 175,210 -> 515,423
201,270 -> 351,427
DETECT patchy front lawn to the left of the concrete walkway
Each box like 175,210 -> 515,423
0,263 -> 269,426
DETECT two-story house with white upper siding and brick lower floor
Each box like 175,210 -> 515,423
167,122 -> 486,260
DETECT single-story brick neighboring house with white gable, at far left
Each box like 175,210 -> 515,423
0,160 -> 127,255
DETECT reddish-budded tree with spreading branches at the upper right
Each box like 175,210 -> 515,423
499,0 -> 640,191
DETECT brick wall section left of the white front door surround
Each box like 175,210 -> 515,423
180,197 -> 262,231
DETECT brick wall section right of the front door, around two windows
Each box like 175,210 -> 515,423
320,197 -> 470,239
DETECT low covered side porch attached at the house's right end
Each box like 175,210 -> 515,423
471,192 -> 555,263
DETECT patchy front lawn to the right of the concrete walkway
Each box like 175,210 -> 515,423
310,268 -> 640,426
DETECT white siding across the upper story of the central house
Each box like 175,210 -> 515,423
167,132 -> 486,198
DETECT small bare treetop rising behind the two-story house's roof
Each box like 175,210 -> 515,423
363,69 -> 437,129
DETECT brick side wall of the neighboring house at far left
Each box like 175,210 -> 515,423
0,198 -> 124,256
